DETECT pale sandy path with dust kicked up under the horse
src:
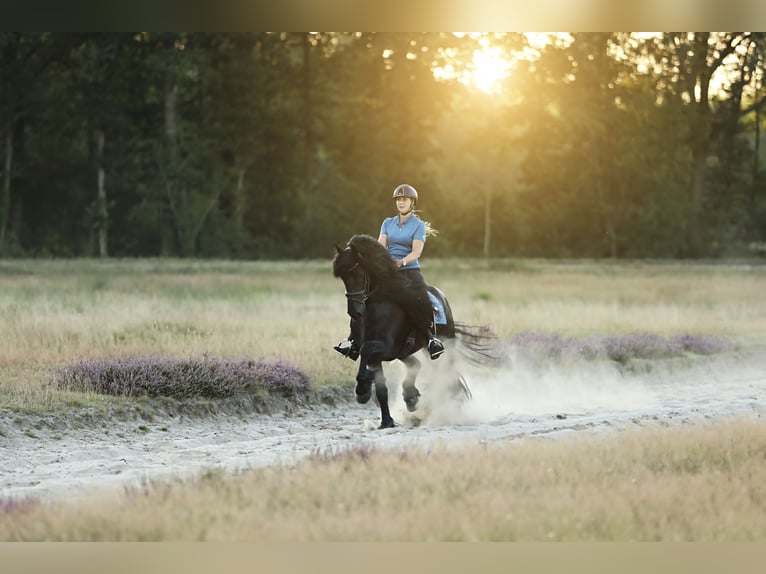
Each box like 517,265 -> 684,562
0,353 -> 766,498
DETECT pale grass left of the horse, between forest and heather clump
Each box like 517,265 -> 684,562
0,261 -> 348,409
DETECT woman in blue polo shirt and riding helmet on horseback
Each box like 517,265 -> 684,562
333,183 -> 444,360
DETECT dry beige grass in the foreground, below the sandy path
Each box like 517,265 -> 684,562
0,419 -> 766,541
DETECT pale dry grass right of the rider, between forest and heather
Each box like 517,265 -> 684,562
429,261 -> 766,338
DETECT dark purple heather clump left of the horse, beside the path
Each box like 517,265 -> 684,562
53,356 -> 309,398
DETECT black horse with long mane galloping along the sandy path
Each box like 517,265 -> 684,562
333,235 -> 489,428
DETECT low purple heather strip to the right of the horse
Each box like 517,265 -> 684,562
509,331 -> 733,363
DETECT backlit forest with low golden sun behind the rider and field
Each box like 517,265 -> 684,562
0,32 -> 766,259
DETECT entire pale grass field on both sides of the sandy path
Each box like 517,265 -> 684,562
0,259 -> 766,541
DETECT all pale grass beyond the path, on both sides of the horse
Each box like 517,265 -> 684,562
0,258 -> 766,410
